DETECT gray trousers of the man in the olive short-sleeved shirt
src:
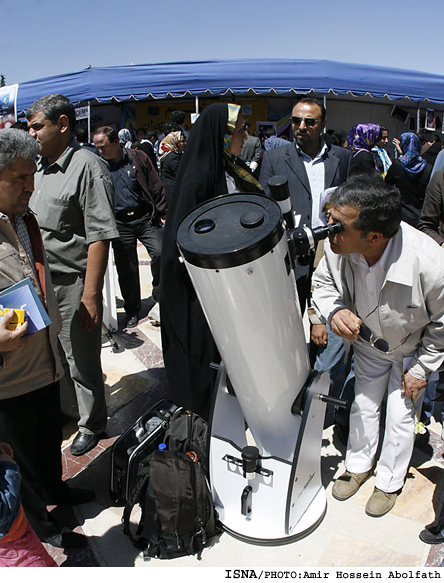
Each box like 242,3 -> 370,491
54,277 -> 107,435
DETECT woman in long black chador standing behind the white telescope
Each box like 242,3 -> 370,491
160,103 -> 262,419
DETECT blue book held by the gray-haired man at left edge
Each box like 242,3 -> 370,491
0,277 -> 51,336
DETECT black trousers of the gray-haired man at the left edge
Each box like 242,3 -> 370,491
0,382 -> 67,539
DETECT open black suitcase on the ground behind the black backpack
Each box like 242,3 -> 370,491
111,400 -> 178,501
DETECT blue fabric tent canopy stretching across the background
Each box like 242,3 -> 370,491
17,59 -> 444,111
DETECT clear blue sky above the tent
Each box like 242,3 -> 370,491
0,0 -> 444,85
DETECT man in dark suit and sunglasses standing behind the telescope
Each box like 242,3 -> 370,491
259,97 -> 351,312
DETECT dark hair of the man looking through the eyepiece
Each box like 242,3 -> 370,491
330,174 -> 402,239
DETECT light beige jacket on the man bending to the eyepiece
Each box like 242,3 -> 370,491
312,223 -> 444,374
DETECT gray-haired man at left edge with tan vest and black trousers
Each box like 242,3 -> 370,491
0,129 -> 94,558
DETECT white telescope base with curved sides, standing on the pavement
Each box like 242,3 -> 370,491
210,364 -> 329,546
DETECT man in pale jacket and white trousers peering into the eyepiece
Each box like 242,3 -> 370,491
313,176 -> 444,517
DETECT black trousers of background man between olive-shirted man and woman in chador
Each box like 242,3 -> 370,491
113,214 -> 162,317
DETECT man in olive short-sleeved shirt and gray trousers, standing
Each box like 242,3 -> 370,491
27,94 -> 119,455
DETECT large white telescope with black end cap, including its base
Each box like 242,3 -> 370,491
177,184 -> 339,545
